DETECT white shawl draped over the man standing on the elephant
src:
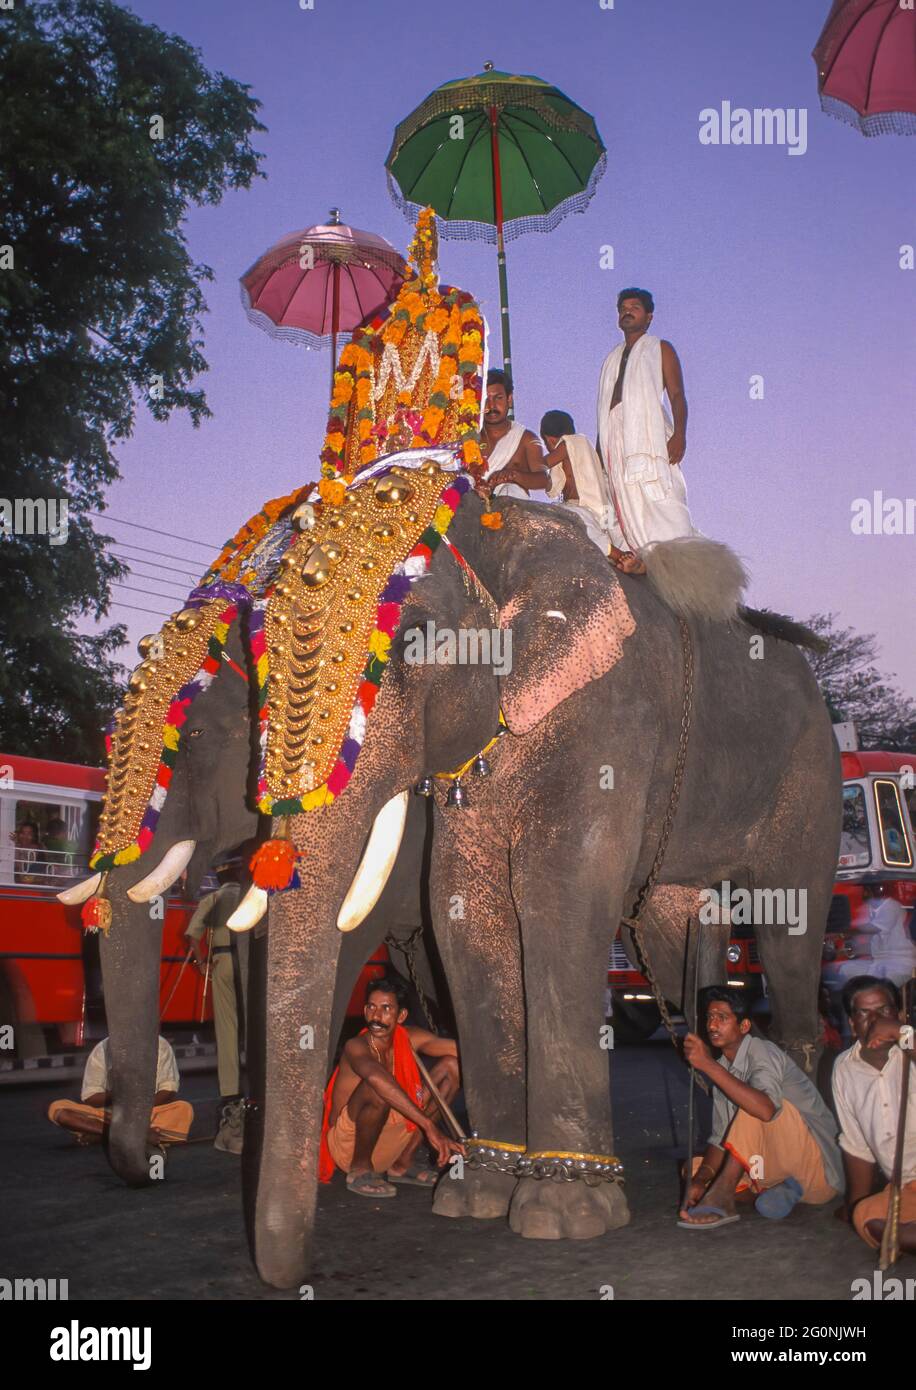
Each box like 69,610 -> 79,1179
598,334 -> 674,493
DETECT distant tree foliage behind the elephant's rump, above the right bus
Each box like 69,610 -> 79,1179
805,613 -> 916,752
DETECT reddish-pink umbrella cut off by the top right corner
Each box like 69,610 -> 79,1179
813,0 -> 916,135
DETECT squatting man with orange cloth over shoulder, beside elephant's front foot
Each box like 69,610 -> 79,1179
318,976 -> 464,1197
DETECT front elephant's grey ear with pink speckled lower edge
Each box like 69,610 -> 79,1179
498,505 -> 637,734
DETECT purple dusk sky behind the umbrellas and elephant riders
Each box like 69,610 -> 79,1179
106,0 -> 916,695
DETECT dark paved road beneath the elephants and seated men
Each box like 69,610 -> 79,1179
0,1041 -> 889,1301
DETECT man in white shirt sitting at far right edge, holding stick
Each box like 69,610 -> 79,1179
833,974 -> 916,1255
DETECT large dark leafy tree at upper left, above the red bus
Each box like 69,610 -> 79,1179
0,0 -> 263,760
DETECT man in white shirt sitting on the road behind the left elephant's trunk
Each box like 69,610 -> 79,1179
47,1037 -> 195,1145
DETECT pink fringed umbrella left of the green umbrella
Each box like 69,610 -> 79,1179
240,207 -> 407,384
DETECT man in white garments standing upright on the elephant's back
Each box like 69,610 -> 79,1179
598,289 -> 696,573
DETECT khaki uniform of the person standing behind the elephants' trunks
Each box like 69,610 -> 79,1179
185,883 -> 249,1095
